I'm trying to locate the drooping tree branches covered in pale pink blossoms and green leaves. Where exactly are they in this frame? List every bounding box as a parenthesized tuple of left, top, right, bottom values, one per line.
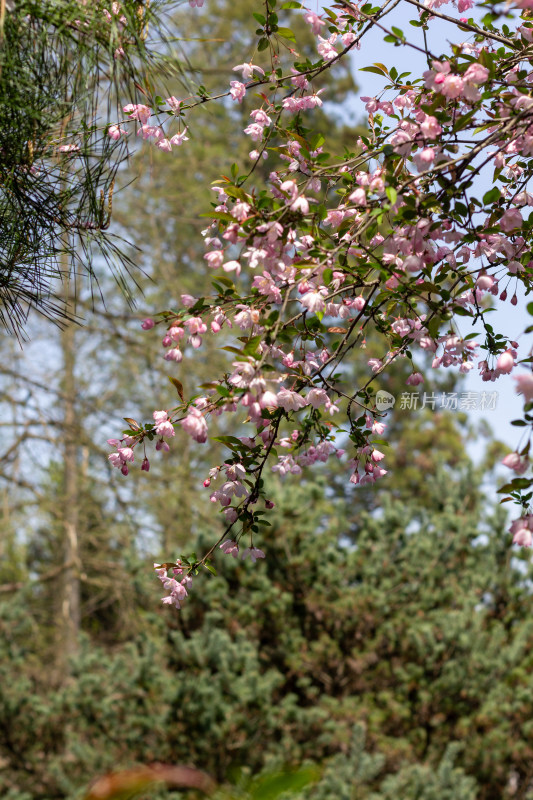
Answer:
(108, 0, 533, 608)
